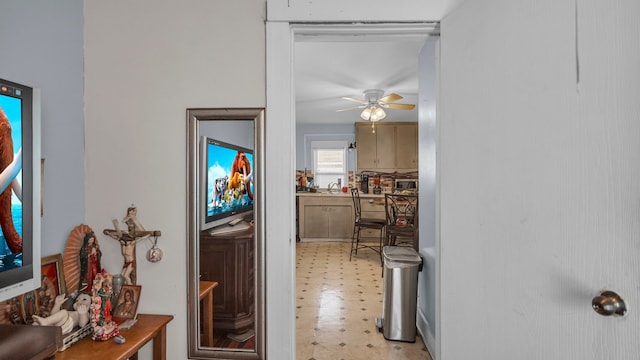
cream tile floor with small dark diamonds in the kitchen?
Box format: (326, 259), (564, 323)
(296, 242), (431, 360)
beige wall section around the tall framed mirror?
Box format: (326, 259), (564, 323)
(85, 0), (264, 359)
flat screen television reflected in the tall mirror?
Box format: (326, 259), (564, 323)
(201, 136), (255, 235)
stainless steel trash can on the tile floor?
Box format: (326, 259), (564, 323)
(376, 246), (422, 342)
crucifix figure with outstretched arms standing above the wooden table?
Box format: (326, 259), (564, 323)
(104, 205), (160, 285)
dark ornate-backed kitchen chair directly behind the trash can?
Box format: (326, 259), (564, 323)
(384, 193), (418, 251)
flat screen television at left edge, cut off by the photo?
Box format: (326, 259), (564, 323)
(0, 79), (41, 300)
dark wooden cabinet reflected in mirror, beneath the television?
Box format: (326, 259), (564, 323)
(200, 228), (255, 333)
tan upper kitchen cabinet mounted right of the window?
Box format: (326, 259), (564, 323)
(356, 123), (418, 172)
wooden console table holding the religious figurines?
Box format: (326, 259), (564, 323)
(55, 314), (173, 360)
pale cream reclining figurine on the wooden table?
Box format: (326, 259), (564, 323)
(33, 293), (91, 335)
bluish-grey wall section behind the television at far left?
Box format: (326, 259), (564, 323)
(0, 0), (85, 256)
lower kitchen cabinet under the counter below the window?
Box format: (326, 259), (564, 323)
(298, 195), (353, 240)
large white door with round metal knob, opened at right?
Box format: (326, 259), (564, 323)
(436, 0), (640, 360)
